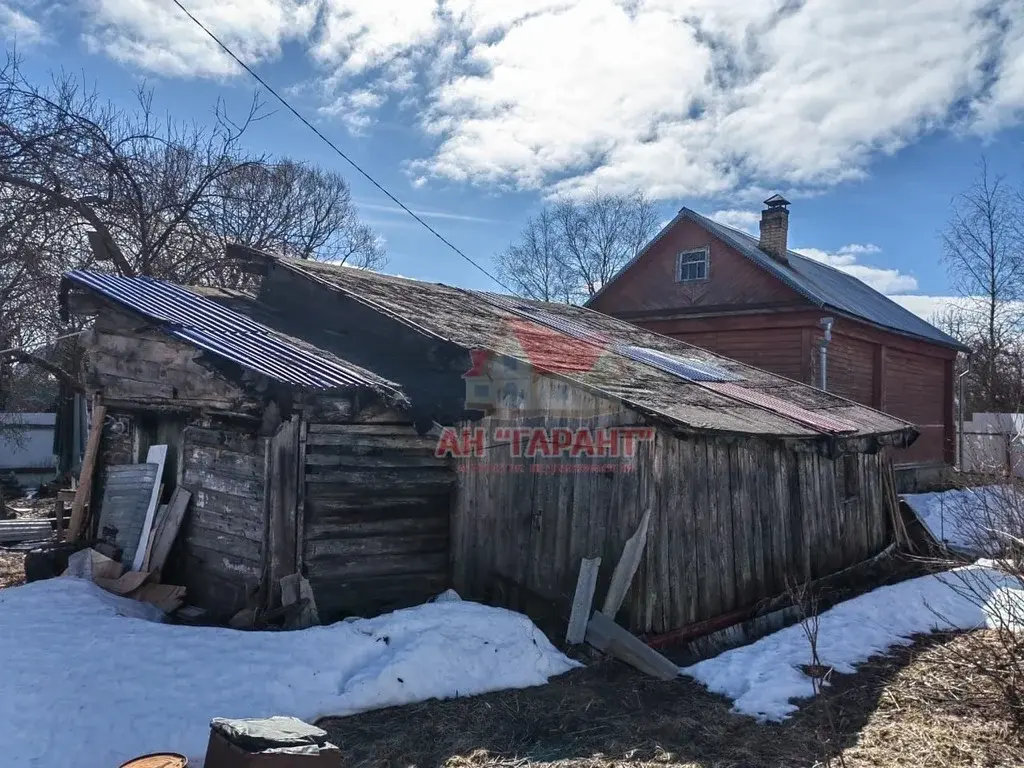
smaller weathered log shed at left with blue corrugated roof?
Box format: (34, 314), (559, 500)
(61, 271), (454, 621)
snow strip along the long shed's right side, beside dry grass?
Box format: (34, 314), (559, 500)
(683, 562), (1024, 720)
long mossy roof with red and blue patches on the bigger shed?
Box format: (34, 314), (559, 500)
(270, 258), (913, 440)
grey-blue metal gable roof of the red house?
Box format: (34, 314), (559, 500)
(591, 208), (967, 351)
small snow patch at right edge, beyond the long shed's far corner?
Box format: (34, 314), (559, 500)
(903, 485), (1024, 557)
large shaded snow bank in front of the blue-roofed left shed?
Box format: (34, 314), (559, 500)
(0, 578), (575, 768)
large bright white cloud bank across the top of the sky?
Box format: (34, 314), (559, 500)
(49, 0), (1024, 198)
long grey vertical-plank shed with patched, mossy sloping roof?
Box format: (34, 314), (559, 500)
(216, 251), (916, 633)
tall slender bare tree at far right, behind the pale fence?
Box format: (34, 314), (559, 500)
(943, 160), (1024, 411)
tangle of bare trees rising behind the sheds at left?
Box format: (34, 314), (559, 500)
(0, 56), (385, 408)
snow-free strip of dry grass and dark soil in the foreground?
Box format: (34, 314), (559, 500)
(322, 636), (1024, 768)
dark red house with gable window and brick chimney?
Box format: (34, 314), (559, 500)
(588, 196), (966, 465)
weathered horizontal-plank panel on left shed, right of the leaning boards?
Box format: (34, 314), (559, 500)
(179, 426), (266, 615)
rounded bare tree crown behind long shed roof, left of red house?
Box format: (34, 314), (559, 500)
(498, 190), (657, 302)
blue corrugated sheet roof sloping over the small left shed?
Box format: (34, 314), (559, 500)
(65, 269), (394, 390)
